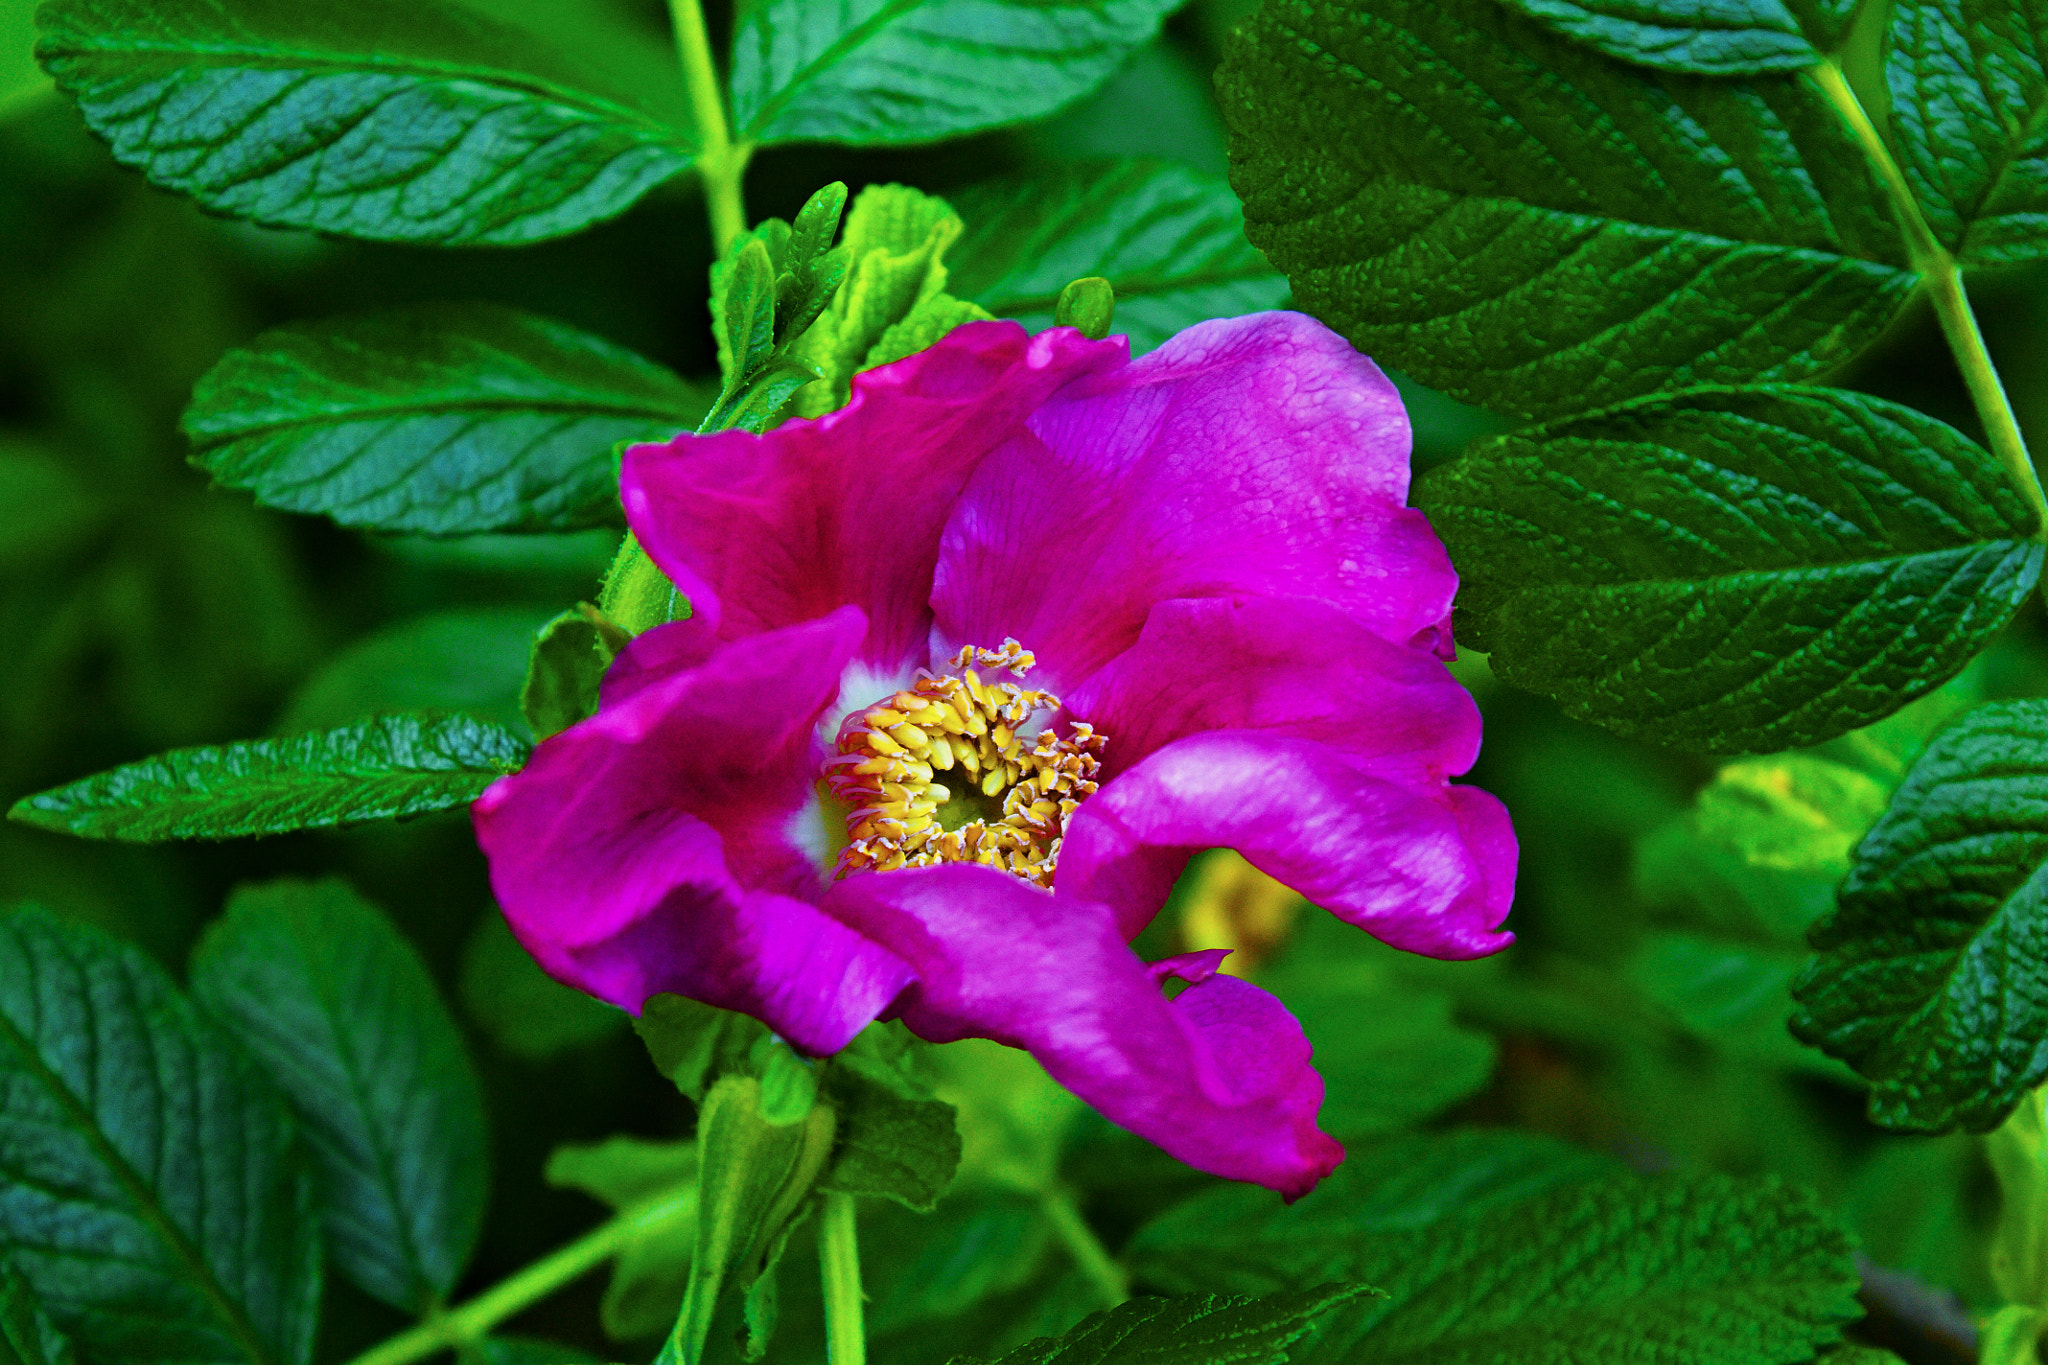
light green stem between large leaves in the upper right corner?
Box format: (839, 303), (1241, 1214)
(1812, 57), (2048, 544)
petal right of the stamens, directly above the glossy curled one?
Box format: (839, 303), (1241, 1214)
(1065, 598), (1481, 784)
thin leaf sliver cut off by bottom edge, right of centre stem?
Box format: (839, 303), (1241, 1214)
(954, 1285), (1378, 1365)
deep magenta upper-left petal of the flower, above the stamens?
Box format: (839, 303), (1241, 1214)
(618, 321), (1128, 671)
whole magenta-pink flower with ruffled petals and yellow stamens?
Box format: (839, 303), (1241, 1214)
(475, 313), (1516, 1197)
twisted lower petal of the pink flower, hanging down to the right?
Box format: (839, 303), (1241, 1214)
(823, 864), (1343, 1197)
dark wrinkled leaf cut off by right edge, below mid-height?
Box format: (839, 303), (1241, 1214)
(1792, 700), (2048, 1132)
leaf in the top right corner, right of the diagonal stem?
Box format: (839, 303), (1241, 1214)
(1884, 0), (2048, 264)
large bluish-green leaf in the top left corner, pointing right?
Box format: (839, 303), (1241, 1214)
(37, 0), (694, 246)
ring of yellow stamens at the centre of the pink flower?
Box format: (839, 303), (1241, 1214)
(825, 641), (1104, 888)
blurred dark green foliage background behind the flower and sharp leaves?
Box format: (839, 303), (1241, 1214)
(0, 0), (2048, 1359)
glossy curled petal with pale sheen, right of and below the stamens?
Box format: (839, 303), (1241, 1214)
(1053, 731), (1516, 958)
